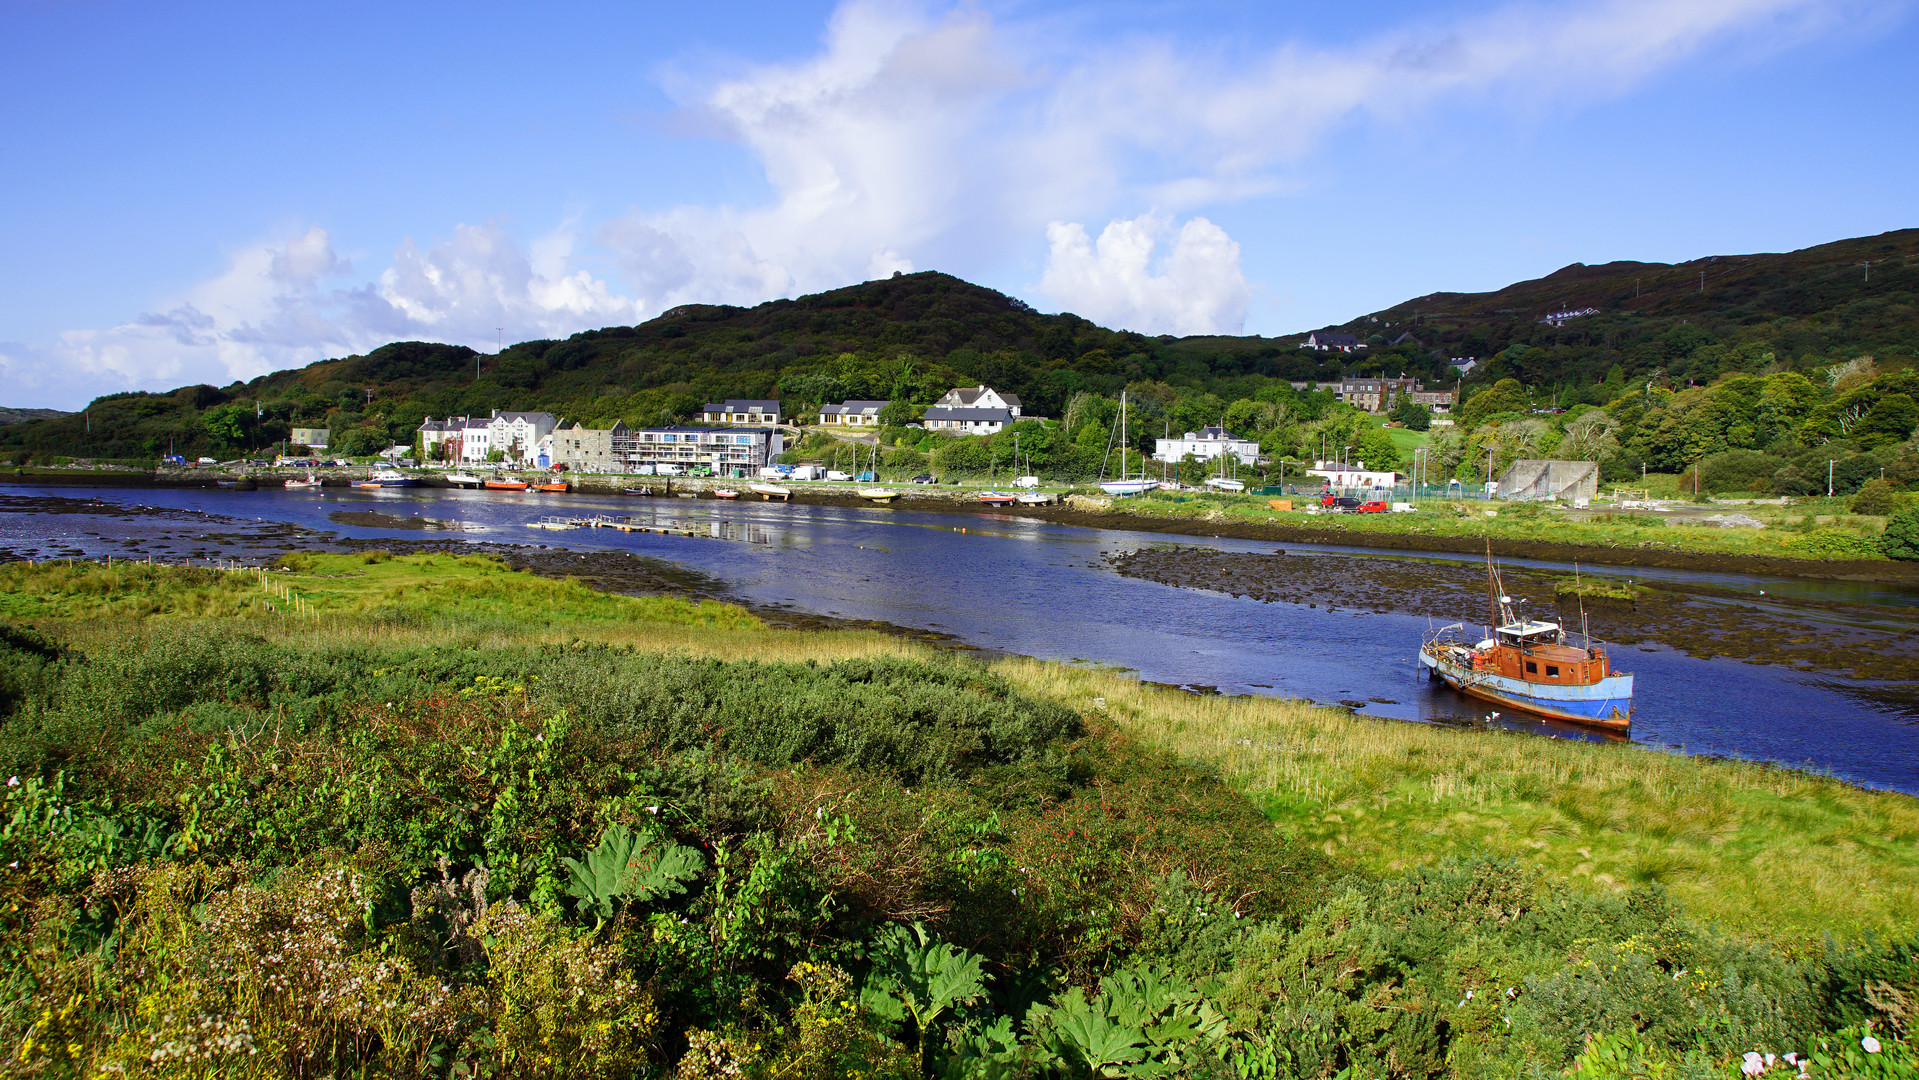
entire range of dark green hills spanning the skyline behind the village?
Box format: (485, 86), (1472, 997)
(0, 230), (1919, 458)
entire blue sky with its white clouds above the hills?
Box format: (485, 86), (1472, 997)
(0, 0), (1919, 409)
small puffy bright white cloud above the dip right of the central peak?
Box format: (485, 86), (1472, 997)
(1040, 215), (1251, 334)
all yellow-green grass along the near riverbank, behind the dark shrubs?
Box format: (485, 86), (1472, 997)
(0, 552), (1919, 938)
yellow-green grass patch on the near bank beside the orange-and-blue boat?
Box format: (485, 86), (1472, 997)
(998, 660), (1919, 938)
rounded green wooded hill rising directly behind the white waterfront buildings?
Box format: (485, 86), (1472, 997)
(0, 272), (1343, 458)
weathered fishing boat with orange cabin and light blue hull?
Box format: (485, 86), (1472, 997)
(1420, 549), (1633, 731)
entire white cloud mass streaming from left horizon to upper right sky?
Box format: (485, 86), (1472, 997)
(14, 0), (1872, 403)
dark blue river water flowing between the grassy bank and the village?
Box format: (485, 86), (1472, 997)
(0, 485), (1919, 794)
